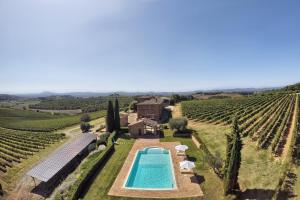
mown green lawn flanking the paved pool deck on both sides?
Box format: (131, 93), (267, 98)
(84, 132), (223, 200)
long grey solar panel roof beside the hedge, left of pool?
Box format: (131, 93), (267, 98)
(27, 133), (96, 182)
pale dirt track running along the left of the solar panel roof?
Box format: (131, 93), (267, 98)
(6, 118), (105, 200)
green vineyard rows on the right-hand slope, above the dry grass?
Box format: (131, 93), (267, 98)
(182, 95), (298, 156)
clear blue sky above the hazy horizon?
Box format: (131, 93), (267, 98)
(0, 0), (300, 93)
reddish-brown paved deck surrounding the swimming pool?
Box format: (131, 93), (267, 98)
(108, 139), (203, 199)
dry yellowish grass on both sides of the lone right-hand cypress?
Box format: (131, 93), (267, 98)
(192, 122), (284, 198)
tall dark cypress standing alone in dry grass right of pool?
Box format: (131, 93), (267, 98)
(224, 118), (242, 195)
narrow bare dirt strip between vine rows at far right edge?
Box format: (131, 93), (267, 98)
(281, 95), (299, 162)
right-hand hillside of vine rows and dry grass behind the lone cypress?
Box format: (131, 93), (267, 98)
(181, 94), (300, 199)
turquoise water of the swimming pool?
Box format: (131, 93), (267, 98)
(125, 147), (176, 190)
